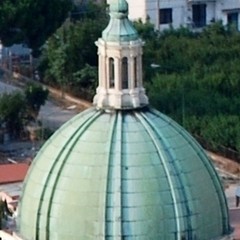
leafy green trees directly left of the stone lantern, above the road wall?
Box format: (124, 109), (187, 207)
(39, 2), (107, 99)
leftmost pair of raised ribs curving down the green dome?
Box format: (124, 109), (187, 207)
(35, 111), (101, 240)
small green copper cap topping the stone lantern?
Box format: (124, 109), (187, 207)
(102, 0), (138, 42)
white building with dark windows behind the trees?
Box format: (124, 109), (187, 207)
(125, 0), (240, 31)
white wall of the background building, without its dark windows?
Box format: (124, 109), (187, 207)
(127, 0), (240, 30)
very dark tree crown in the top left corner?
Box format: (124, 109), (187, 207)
(0, 0), (72, 54)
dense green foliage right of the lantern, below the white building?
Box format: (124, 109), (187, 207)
(144, 23), (240, 154)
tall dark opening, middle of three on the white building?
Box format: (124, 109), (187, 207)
(192, 4), (206, 28)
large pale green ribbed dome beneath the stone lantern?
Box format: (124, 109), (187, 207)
(18, 107), (229, 240)
